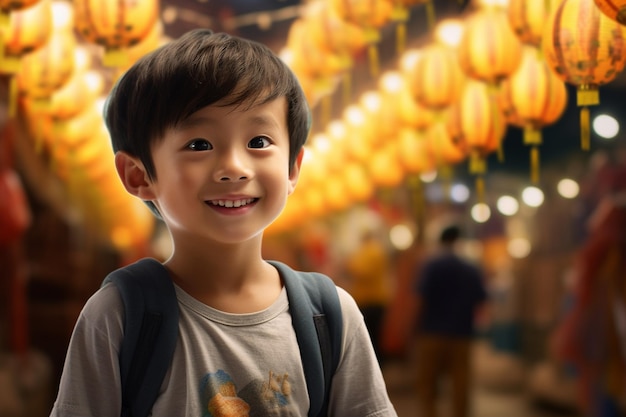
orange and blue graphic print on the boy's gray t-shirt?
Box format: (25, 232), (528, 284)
(200, 369), (296, 417)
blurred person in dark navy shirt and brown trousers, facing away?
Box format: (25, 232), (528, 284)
(414, 225), (487, 417)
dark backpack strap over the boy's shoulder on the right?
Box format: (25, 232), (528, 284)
(269, 261), (343, 417)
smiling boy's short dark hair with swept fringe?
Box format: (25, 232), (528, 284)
(104, 29), (311, 211)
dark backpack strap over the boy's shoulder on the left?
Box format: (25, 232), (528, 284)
(102, 258), (178, 417)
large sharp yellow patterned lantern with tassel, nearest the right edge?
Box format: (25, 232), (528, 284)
(542, 0), (626, 150)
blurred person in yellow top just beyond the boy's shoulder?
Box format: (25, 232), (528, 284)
(345, 230), (392, 363)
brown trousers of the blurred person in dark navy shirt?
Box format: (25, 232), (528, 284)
(417, 334), (471, 417)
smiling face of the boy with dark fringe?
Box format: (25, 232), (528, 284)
(130, 97), (301, 243)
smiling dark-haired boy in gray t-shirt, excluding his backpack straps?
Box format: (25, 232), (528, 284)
(52, 30), (396, 417)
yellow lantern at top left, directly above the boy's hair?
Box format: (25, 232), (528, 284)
(73, 0), (159, 67)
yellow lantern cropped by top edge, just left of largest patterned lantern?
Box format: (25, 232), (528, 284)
(507, 0), (555, 47)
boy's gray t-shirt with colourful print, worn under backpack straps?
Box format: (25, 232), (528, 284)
(51, 274), (396, 417)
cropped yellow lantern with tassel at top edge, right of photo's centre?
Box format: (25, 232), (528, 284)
(330, 0), (393, 77)
